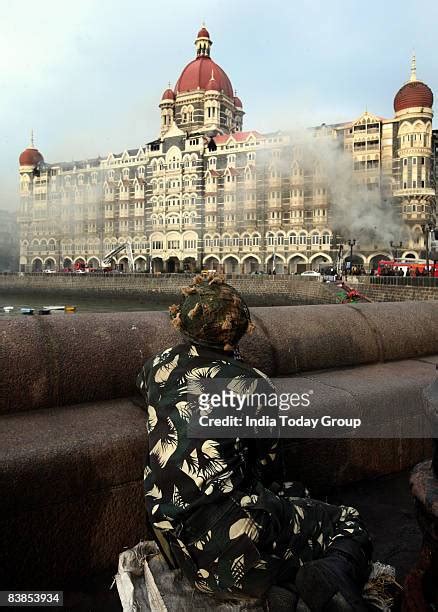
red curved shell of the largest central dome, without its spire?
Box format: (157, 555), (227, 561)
(175, 56), (233, 99)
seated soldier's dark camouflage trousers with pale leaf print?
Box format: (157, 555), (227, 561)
(172, 484), (370, 597)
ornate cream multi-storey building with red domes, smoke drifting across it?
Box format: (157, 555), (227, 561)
(19, 27), (438, 273)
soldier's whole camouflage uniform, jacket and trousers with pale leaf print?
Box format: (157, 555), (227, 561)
(137, 276), (368, 596)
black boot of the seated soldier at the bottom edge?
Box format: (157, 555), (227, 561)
(295, 538), (370, 612)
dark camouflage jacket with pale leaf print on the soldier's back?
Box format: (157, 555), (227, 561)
(137, 343), (277, 530)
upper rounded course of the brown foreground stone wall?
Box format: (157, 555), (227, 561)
(0, 302), (438, 414)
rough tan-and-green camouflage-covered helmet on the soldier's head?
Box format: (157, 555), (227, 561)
(169, 275), (254, 350)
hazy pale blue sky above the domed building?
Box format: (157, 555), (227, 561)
(0, 0), (438, 209)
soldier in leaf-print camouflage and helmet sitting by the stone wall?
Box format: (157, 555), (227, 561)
(137, 276), (371, 612)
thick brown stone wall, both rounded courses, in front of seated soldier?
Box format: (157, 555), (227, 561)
(0, 304), (438, 589)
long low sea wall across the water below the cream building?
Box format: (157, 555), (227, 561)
(0, 274), (337, 306)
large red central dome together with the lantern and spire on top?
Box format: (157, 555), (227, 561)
(175, 27), (234, 99)
